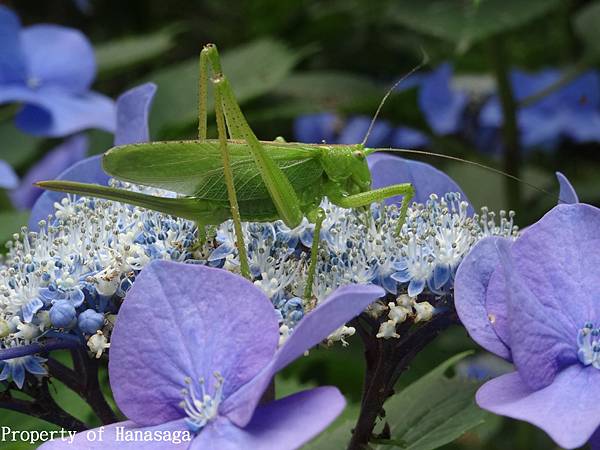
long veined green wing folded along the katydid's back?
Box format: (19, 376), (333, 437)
(103, 140), (323, 201)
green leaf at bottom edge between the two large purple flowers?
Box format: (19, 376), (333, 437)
(377, 352), (489, 450)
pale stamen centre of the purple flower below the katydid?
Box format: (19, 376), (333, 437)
(180, 372), (224, 433)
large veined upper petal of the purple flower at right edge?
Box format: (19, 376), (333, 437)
(498, 203), (600, 389)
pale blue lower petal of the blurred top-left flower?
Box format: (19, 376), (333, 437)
(14, 88), (116, 137)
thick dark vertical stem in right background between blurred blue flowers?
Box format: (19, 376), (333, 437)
(489, 36), (521, 211)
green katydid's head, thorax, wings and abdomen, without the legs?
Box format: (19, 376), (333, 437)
(98, 140), (378, 226)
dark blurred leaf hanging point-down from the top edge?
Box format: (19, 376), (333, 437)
(392, 0), (560, 52)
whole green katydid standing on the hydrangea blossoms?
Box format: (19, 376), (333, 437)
(38, 45), (414, 288)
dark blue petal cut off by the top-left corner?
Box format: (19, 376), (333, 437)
(0, 5), (26, 84)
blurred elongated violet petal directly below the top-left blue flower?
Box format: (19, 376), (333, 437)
(10, 134), (88, 209)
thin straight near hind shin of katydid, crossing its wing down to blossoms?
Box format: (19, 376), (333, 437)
(215, 79), (250, 279)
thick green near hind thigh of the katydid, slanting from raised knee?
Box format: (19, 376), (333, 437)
(203, 46), (304, 227)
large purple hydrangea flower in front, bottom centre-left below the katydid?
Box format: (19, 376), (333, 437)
(41, 261), (383, 450)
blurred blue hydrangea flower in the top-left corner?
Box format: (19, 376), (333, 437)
(0, 6), (116, 137)
